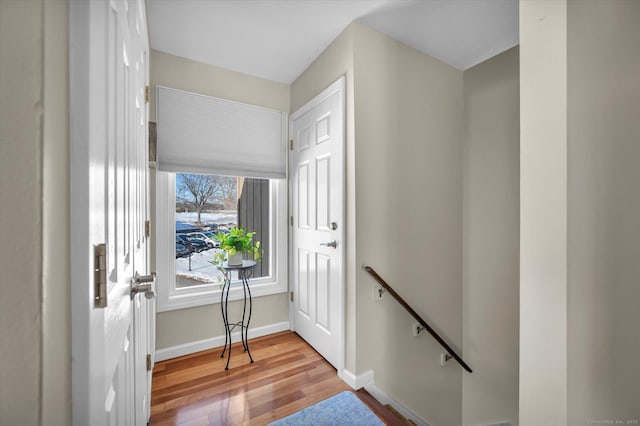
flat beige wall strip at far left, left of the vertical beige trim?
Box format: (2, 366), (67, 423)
(0, 1), (44, 425)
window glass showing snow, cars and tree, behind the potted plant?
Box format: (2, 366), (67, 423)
(176, 174), (271, 288)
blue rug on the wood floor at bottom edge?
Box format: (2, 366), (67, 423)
(269, 391), (384, 426)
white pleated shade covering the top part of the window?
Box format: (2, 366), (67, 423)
(156, 86), (287, 179)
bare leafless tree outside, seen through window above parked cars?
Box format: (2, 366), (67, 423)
(176, 174), (237, 224)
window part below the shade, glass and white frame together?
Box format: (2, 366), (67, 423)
(156, 171), (287, 311)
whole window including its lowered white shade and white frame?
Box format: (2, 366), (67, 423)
(156, 86), (288, 311)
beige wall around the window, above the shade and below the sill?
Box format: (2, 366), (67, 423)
(150, 50), (289, 349)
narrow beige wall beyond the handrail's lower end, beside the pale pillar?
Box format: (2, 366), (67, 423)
(462, 47), (520, 426)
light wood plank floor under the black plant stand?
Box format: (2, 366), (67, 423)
(150, 331), (350, 425)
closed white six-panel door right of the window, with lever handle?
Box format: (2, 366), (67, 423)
(290, 77), (345, 371)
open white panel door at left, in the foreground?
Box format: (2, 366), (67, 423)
(69, 0), (154, 426)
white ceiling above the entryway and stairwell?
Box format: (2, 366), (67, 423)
(147, 0), (518, 84)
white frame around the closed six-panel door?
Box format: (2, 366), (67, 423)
(287, 75), (347, 380)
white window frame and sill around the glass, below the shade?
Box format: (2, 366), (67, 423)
(155, 171), (288, 312)
